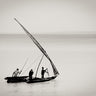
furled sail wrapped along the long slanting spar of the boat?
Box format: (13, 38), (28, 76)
(14, 18), (59, 76)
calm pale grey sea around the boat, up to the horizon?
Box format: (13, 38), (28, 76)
(0, 34), (96, 96)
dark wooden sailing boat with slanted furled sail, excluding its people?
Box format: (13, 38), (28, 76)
(5, 18), (59, 83)
